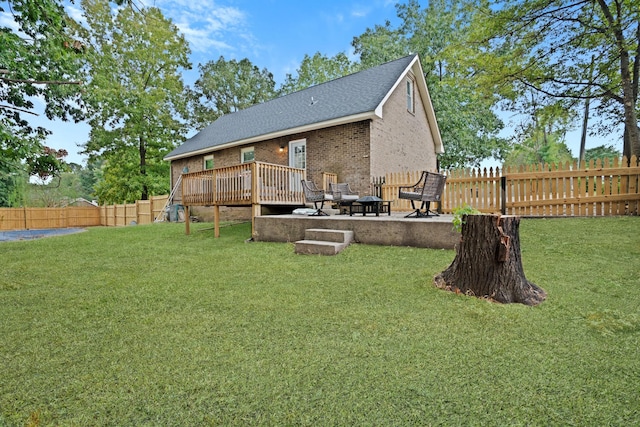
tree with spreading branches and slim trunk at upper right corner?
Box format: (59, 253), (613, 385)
(474, 0), (640, 157)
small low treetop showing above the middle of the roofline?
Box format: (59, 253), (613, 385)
(280, 52), (359, 95)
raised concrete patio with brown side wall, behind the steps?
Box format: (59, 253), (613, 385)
(253, 212), (460, 249)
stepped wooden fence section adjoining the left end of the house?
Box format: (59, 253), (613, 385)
(99, 194), (169, 227)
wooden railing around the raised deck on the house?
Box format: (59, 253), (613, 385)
(182, 162), (305, 206)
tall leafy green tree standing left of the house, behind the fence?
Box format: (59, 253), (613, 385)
(82, 0), (190, 203)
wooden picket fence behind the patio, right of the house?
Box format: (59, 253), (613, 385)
(382, 156), (640, 216)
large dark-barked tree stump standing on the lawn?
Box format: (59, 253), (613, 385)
(434, 215), (547, 305)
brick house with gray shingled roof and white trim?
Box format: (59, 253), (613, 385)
(165, 55), (444, 217)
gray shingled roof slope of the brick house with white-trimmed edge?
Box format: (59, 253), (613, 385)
(165, 55), (415, 159)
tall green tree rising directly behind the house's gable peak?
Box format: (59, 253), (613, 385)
(352, 0), (508, 168)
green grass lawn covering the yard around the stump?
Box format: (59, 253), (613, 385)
(0, 218), (640, 426)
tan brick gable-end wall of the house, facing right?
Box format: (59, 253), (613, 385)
(371, 74), (437, 176)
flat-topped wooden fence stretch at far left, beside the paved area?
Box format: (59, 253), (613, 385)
(0, 206), (100, 230)
